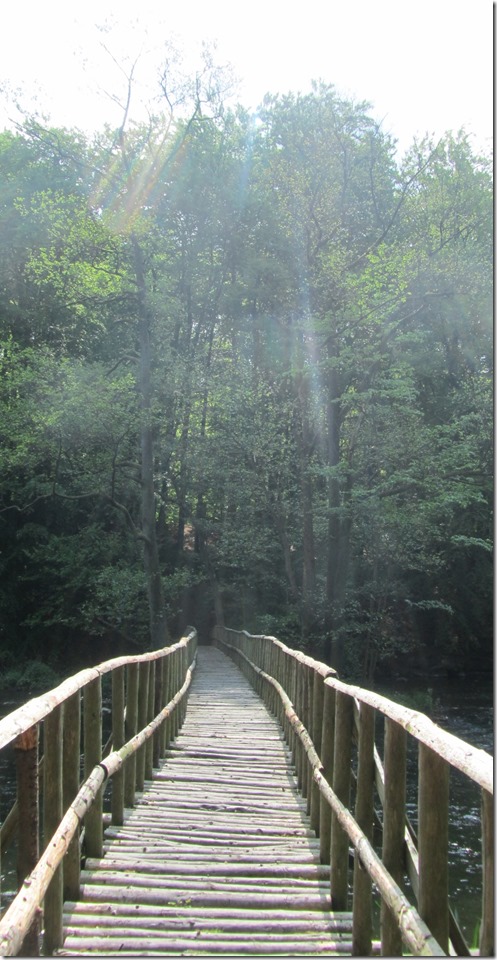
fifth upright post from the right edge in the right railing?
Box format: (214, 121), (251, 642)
(331, 691), (354, 910)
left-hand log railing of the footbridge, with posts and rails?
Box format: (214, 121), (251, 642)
(0, 630), (197, 957)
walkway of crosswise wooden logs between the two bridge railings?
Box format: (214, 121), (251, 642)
(59, 647), (352, 956)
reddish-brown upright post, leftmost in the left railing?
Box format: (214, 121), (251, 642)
(14, 724), (40, 957)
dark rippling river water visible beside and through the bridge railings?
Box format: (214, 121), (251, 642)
(0, 678), (494, 946)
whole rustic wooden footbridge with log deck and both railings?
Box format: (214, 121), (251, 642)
(0, 627), (494, 957)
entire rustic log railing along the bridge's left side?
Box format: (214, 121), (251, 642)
(0, 629), (197, 956)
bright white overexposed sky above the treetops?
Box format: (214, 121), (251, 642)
(0, 0), (493, 158)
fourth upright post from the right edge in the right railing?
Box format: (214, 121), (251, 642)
(352, 703), (375, 957)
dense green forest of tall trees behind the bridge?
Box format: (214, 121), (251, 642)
(0, 60), (493, 682)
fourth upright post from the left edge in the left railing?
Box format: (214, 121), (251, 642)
(83, 677), (103, 858)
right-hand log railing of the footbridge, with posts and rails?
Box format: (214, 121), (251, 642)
(215, 627), (494, 956)
